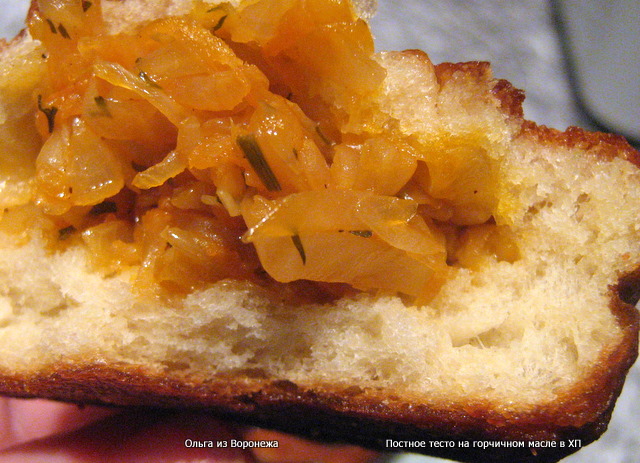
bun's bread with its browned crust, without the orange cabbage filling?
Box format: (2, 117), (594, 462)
(0, 0), (640, 461)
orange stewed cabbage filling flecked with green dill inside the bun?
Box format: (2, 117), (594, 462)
(5, 0), (517, 302)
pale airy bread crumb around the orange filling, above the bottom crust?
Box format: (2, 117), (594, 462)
(0, 2), (640, 416)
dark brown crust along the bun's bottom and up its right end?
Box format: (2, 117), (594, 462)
(0, 286), (639, 462)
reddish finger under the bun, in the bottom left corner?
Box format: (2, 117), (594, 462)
(0, 409), (255, 463)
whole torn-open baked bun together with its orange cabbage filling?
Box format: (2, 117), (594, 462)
(0, 0), (640, 462)
